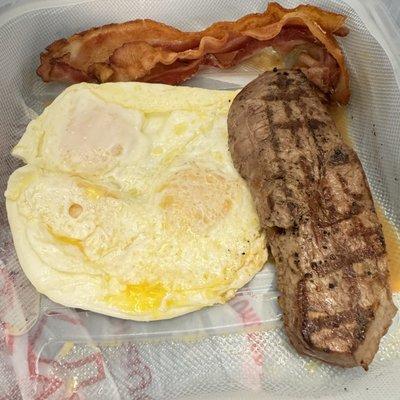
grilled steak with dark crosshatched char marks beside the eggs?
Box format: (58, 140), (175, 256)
(228, 71), (396, 369)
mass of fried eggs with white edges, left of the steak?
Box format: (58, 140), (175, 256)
(6, 83), (267, 320)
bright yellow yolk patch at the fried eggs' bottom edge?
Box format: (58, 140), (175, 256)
(105, 283), (167, 313)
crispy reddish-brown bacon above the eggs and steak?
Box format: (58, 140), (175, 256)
(37, 3), (350, 103)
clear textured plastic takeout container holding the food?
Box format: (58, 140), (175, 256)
(0, 0), (400, 400)
